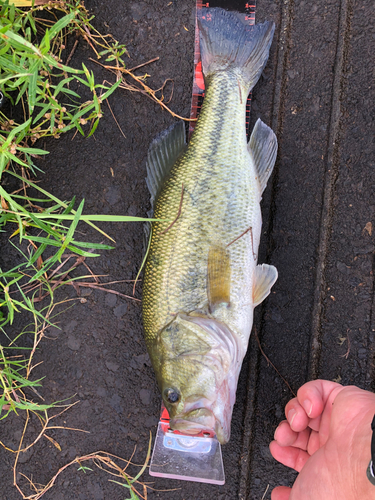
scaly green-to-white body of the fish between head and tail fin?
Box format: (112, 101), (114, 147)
(143, 74), (260, 342)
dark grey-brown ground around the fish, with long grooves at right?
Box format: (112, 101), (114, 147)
(0, 0), (375, 500)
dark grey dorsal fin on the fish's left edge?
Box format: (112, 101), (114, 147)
(146, 121), (186, 216)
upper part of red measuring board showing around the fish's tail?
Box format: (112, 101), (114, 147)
(189, 0), (256, 137)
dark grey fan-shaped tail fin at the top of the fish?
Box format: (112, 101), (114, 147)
(198, 8), (275, 91)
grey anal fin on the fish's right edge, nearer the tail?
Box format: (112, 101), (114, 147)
(248, 119), (277, 193)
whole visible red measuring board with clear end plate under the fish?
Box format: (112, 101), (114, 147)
(149, 0), (255, 485)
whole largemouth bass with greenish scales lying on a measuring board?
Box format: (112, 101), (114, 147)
(142, 8), (277, 444)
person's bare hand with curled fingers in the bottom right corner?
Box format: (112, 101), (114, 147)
(270, 380), (375, 500)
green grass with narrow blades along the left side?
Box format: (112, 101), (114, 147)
(0, 0), (150, 419)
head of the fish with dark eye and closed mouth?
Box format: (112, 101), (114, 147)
(157, 314), (242, 443)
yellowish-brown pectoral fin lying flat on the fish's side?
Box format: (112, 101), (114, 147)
(207, 245), (231, 312)
